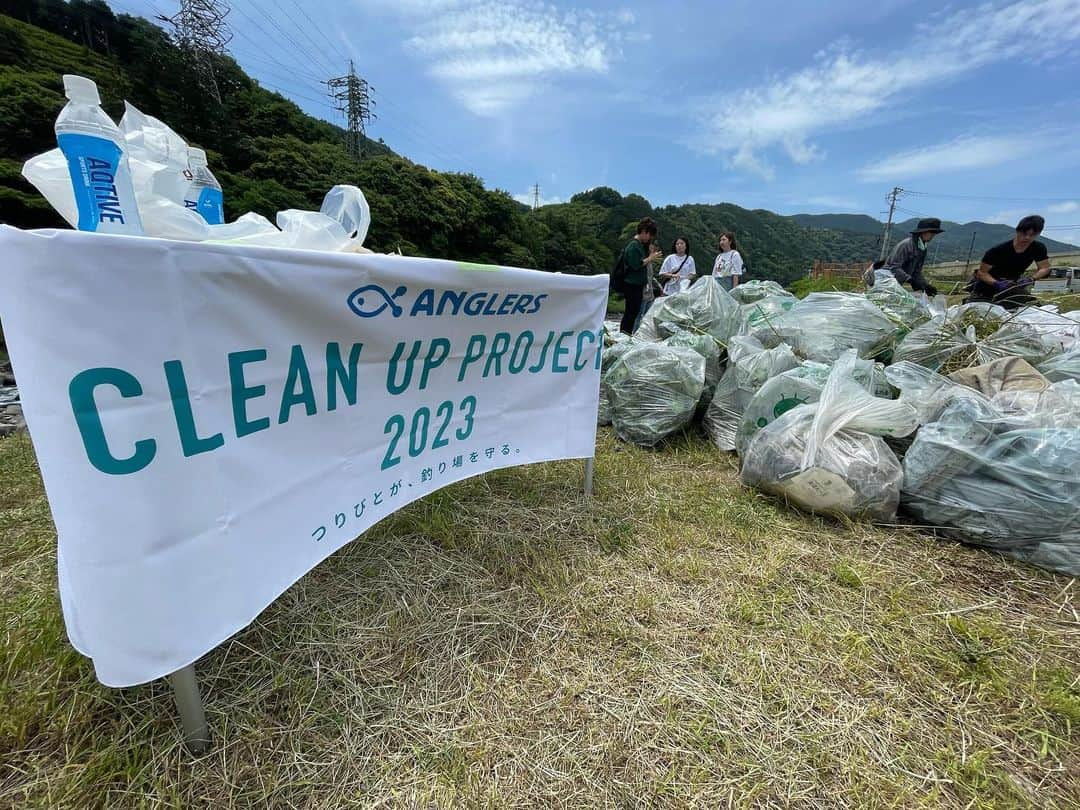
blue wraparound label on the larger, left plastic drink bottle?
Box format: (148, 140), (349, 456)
(56, 133), (143, 233)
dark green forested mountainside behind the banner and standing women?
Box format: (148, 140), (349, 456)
(0, 0), (1067, 283)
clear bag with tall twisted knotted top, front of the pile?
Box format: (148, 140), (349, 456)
(741, 351), (917, 521)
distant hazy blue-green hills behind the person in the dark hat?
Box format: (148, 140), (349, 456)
(788, 214), (1077, 261)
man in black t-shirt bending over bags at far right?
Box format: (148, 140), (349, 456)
(967, 214), (1050, 309)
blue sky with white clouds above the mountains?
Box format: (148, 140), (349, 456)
(113, 0), (1080, 244)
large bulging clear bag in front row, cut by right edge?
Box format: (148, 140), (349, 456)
(903, 381), (1080, 577)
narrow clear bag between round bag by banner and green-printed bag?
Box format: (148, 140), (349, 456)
(702, 336), (799, 451)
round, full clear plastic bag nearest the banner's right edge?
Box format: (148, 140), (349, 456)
(605, 340), (705, 447)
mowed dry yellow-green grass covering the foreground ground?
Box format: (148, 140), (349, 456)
(0, 429), (1080, 809)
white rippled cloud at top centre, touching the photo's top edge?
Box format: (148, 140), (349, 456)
(380, 0), (636, 117)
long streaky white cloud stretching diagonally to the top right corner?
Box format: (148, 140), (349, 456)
(693, 0), (1080, 177)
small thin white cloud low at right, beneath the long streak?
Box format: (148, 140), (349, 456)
(859, 133), (1058, 183)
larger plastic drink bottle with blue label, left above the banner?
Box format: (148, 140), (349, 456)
(56, 75), (143, 234)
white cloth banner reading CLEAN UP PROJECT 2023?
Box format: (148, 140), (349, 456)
(0, 228), (607, 687)
